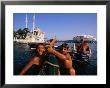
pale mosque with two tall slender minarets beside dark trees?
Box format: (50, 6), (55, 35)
(14, 14), (45, 43)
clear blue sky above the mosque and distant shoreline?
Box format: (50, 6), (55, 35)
(13, 13), (97, 40)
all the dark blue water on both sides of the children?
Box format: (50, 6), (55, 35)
(13, 42), (97, 75)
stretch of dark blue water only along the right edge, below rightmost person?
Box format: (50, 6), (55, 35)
(74, 43), (97, 75)
